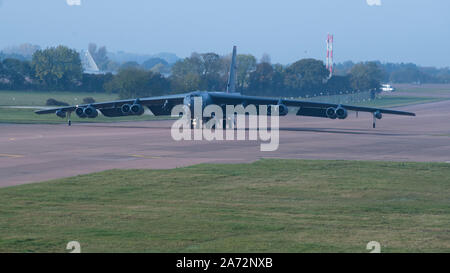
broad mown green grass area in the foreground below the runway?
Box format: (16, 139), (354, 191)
(0, 160), (450, 252)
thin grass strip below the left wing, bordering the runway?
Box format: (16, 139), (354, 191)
(0, 107), (171, 124)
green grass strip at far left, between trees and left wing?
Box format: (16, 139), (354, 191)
(0, 90), (118, 106)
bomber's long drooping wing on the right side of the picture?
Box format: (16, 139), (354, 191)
(210, 92), (416, 116)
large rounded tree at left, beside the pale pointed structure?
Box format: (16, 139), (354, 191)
(31, 46), (83, 89)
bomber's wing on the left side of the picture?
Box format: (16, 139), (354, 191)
(35, 94), (186, 115)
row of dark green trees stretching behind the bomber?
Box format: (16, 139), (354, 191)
(0, 46), (384, 98)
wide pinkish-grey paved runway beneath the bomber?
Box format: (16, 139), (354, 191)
(0, 101), (450, 187)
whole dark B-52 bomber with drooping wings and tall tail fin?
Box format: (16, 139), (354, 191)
(36, 46), (415, 128)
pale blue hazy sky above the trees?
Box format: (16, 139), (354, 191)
(0, 0), (450, 67)
